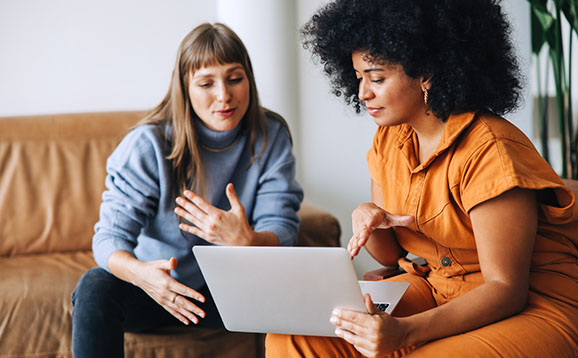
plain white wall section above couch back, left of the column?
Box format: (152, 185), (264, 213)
(0, 0), (216, 115)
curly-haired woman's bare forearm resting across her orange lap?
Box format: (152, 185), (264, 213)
(399, 281), (527, 346)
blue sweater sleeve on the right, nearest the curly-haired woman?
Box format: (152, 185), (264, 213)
(253, 120), (303, 246)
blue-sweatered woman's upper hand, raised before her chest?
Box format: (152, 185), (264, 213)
(175, 183), (255, 246)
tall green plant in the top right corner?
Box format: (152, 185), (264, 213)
(528, 0), (578, 179)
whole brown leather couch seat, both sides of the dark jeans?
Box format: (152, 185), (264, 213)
(0, 251), (264, 358)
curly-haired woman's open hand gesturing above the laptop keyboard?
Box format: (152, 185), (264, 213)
(347, 203), (414, 258)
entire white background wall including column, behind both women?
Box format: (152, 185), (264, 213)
(0, 0), (531, 273)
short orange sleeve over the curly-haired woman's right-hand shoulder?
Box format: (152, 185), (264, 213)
(450, 114), (560, 210)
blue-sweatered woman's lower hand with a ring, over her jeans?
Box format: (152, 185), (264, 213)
(108, 251), (205, 325)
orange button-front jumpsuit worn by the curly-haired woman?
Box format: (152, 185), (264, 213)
(266, 112), (578, 358)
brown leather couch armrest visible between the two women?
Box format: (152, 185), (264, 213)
(297, 199), (341, 247)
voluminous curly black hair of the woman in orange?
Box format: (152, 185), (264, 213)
(301, 0), (522, 120)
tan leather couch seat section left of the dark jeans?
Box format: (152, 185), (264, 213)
(0, 251), (95, 358)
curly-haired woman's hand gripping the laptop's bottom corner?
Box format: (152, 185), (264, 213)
(330, 294), (405, 357)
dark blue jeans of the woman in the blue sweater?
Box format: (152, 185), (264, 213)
(72, 268), (223, 358)
